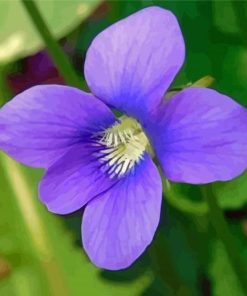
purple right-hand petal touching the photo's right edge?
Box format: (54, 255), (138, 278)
(146, 88), (247, 184)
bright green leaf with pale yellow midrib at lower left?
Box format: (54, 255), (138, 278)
(0, 154), (151, 296)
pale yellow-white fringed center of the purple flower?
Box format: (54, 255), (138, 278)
(93, 117), (148, 178)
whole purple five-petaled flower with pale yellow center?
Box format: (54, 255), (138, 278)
(0, 7), (247, 270)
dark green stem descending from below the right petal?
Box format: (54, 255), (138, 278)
(203, 185), (247, 295)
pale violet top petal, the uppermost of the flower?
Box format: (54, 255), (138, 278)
(85, 7), (185, 119)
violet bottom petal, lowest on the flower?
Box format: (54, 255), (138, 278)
(82, 155), (162, 270)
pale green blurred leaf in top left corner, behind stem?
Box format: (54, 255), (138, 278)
(0, 0), (102, 64)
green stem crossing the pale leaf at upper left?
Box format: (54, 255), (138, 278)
(21, 0), (83, 88)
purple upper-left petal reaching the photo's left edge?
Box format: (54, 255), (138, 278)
(0, 85), (115, 167)
